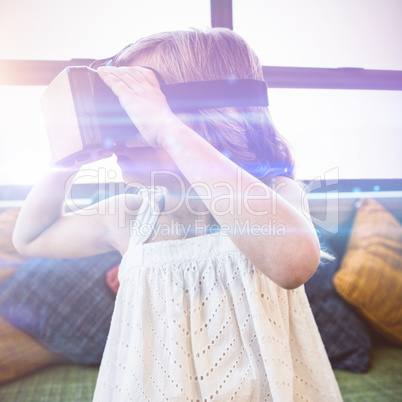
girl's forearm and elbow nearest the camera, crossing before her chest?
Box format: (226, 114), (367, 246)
(164, 124), (320, 289)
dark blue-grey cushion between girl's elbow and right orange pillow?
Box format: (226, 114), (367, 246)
(305, 232), (371, 373)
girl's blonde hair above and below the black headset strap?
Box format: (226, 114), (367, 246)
(116, 28), (294, 182)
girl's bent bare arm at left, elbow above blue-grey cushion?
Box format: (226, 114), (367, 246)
(13, 169), (137, 258)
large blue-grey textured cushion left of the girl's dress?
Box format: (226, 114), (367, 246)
(0, 252), (121, 365)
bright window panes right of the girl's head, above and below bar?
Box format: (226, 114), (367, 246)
(233, 0), (402, 179)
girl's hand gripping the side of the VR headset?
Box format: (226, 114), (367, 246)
(98, 66), (178, 148)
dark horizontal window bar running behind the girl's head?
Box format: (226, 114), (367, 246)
(0, 59), (402, 91)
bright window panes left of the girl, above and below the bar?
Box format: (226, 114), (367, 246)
(0, 0), (211, 185)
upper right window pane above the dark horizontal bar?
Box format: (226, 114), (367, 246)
(233, 0), (402, 70)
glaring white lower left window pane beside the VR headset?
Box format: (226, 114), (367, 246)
(0, 86), (122, 185)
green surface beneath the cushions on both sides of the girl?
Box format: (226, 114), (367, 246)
(0, 346), (402, 402)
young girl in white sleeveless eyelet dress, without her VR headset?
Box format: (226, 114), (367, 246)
(14, 29), (341, 402)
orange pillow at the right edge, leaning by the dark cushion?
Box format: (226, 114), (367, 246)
(334, 199), (402, 345)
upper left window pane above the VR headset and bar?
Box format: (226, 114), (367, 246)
(0, 0), (210, 60)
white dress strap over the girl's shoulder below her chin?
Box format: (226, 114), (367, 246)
(129, 188), (165, 247)
